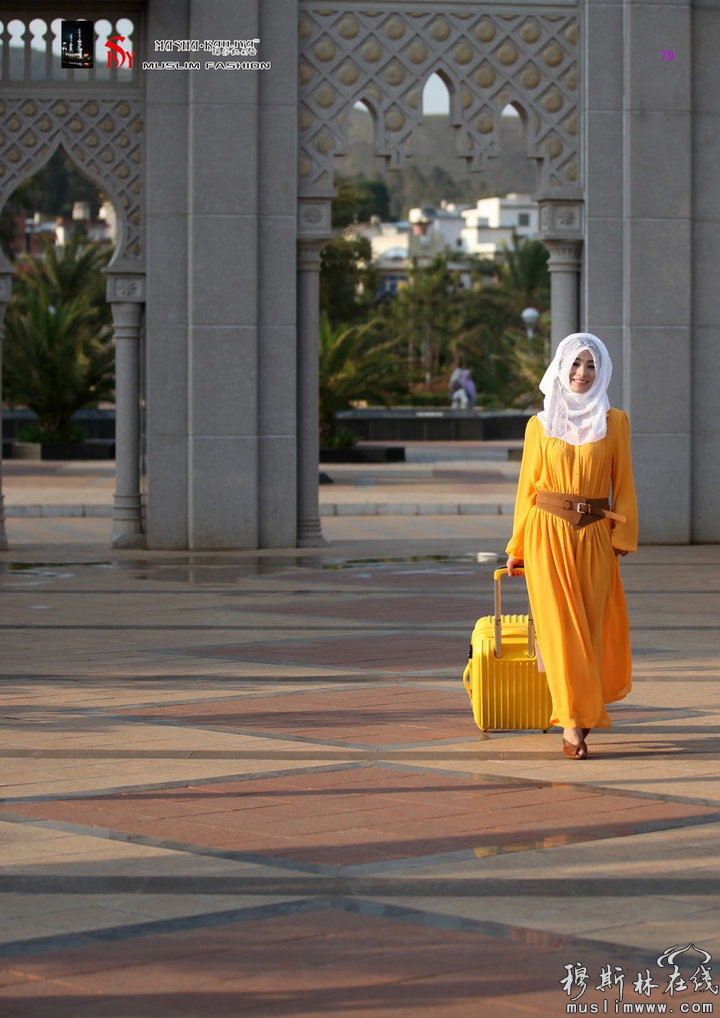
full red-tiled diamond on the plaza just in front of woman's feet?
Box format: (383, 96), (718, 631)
(13, 767), (720, 866)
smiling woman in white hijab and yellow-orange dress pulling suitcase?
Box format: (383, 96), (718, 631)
(506, 332), (638, 759)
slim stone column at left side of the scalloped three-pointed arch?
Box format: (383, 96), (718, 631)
(297, 240), (326, 548)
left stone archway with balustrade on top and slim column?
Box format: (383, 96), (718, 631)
(0, 3), (145, 547)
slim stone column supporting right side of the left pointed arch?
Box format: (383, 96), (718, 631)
(108, 276), (146, 548)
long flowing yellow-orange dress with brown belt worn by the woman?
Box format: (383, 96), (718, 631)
(506, 409), (638, 728)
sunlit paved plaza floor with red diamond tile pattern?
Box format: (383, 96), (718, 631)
(0, 450), (720, 1018)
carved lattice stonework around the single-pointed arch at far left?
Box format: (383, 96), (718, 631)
(0, 96), (145, 269)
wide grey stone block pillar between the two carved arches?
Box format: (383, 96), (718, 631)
(146, 0), (297, 549)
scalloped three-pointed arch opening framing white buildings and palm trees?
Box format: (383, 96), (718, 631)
(321, 94), (548, 430)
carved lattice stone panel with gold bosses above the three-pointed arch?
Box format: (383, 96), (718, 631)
(299, 0), (579, 195)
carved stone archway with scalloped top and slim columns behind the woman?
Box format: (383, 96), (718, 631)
(298, 0), (583, 545)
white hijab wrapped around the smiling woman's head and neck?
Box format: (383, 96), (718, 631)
(538, 332), (612, 445)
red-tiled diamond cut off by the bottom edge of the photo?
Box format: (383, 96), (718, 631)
(0, 910), (631, 1018)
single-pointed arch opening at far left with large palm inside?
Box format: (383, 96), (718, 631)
(0, 147), (118, 541)
